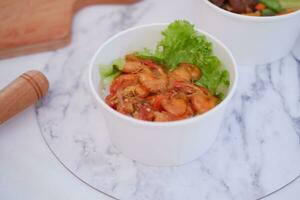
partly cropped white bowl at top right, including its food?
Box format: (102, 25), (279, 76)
(196, 0), (300, 65)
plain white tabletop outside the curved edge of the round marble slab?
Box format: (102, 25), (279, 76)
(0, 104), (300, 200)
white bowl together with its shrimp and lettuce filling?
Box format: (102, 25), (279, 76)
(89, 20), (238, 166)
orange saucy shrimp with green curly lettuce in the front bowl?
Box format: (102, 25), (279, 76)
(100, 20), (230, 122)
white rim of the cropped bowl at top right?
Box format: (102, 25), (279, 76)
(201, 0), (300, 22)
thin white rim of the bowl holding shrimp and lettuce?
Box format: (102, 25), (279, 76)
(88, 23), (238, 127)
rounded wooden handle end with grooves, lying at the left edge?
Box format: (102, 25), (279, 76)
(0, 70), (49, 124)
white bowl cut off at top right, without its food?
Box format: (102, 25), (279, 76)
(196, 0), (300, 65)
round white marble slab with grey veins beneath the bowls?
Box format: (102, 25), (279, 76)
(0, 0), (300, 200)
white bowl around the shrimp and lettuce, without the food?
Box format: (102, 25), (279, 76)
(89, 24), (238, 166)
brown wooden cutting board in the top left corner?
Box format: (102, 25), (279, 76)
(0, 0), (137, 58)
